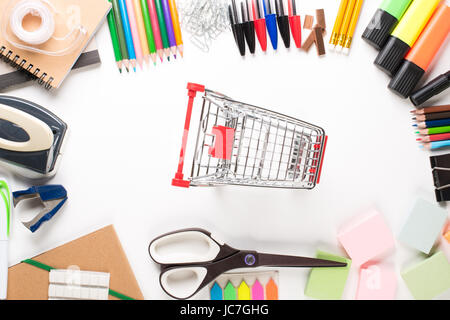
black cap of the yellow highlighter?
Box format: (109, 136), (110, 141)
(374, 36), (411, 77)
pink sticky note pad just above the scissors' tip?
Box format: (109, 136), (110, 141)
(338, 209), (395, 265)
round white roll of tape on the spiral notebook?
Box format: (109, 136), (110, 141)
(9, 0), (55, 45)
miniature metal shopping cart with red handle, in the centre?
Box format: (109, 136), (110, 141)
(172, 83), (327, 189)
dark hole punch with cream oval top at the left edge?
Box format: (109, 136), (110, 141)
(0, 95), (67, 179)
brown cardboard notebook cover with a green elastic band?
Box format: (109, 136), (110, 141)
(7, 225), (144, 300)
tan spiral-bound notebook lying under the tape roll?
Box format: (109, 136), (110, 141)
(0, 0), (111, 89)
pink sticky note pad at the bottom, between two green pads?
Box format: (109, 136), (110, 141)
(356, 264), (397, 300)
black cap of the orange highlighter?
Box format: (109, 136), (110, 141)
(388, 60), (425, 99)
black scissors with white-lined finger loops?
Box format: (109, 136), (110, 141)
(148, 228), (347, 300)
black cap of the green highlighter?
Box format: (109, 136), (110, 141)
(362, 9), (398, 50)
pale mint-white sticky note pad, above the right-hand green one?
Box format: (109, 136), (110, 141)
(399, 199), (447, 254)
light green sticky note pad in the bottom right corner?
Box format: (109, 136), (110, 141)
(402, 252), (450, 300)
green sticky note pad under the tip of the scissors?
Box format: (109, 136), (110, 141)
(305, 250), (352, 300)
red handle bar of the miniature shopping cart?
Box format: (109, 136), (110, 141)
(172, 82), (205, 188)
